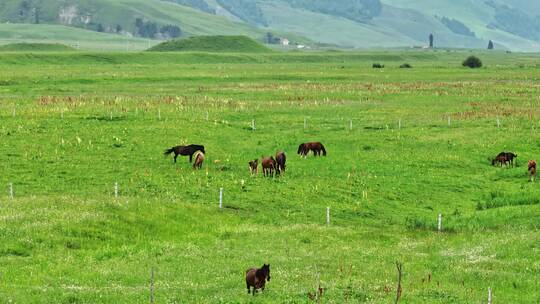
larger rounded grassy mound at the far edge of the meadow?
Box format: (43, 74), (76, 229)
(149, 36), (270, 53)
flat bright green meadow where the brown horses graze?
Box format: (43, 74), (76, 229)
(0, 50), (540, 303)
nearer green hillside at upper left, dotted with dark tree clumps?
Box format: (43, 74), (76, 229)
(0, 0), (264, 38)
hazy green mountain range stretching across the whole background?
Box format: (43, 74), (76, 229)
(0, 0), (540, 51)
